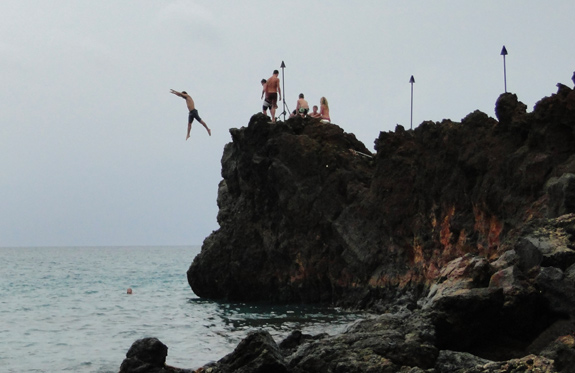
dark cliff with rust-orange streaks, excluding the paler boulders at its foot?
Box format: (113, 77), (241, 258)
(188, 86), (575, 309)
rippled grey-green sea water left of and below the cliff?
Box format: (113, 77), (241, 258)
(0, 246), (360, 372)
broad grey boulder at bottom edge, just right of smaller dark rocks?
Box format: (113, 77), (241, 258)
(288, 312), (438, 373)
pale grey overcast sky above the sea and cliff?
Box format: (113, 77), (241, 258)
(0, 0), (575, 247)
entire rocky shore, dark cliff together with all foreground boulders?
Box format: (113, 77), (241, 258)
(120, 80), (575, 373)
